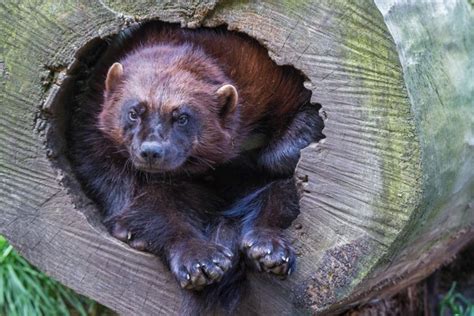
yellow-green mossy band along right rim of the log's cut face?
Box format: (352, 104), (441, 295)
(340, 0), (421, 294)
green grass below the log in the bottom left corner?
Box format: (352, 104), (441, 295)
(0, 236), (107, 316)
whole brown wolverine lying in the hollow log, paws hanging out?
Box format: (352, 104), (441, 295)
(68, 23), (324, 315)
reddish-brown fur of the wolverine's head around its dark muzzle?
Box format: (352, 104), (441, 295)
(99, 45), (239, 173)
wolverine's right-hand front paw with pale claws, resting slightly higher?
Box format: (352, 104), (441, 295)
(241, 229), (295, 277)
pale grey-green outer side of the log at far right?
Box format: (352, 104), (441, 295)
(378, 1), (474, 249)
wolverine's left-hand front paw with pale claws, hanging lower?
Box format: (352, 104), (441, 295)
(170, 241), (234, 290)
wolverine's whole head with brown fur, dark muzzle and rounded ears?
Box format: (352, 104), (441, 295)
(99, 45), (239, 173)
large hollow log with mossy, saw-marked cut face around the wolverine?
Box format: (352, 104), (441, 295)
(0, 0), (474, 315)
